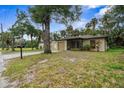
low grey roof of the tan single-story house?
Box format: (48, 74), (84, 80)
(62, 35), (107, 40)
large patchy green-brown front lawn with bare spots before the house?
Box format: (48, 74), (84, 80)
(3, 50), (124, 88)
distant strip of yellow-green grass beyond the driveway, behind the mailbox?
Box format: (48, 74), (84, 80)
(0, 48), (41, 54)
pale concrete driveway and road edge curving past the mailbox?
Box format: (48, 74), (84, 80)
(0, 51), (43, 88)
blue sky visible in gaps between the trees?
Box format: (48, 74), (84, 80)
(0, 5), (108, 32)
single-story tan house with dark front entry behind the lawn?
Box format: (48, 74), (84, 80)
(51, 35), (107, 52)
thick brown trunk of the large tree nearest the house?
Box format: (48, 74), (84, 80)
(44, 16), (51, 54)
